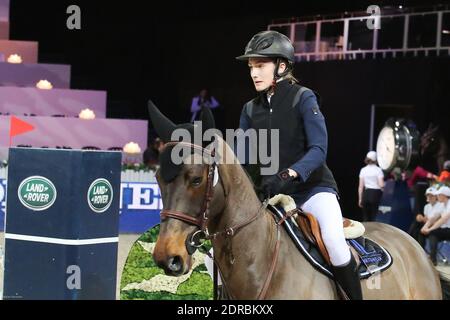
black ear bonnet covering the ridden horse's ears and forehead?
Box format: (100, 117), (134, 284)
(148, 100), (215, 183)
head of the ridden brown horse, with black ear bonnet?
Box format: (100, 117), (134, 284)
(149, 103), (230, 276)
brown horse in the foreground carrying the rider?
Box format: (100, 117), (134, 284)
(151, 102), (442, 300)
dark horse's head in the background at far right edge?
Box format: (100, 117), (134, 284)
(420, 123), (450, 172)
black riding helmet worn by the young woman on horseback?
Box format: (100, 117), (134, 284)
(236, 30), (295, 80)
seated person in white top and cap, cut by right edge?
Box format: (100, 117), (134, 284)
(421, 186), (450, 265)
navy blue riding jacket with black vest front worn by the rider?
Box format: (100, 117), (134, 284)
(239, 80), (338, 205)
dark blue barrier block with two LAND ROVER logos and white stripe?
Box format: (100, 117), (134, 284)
(3, 148), (121, 299)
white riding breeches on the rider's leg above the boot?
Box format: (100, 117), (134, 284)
(301, 192), (350, 266)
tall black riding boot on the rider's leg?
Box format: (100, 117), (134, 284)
(333, 255), (362, 300)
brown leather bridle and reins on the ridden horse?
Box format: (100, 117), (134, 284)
(156, 141), (284, 299)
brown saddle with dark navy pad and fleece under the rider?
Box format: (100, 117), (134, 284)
(269, 194), (392, 279)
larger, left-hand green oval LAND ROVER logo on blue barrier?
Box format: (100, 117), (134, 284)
(17, 176), (56, 211)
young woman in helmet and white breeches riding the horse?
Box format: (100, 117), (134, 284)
(237, 31), (362, 300)
